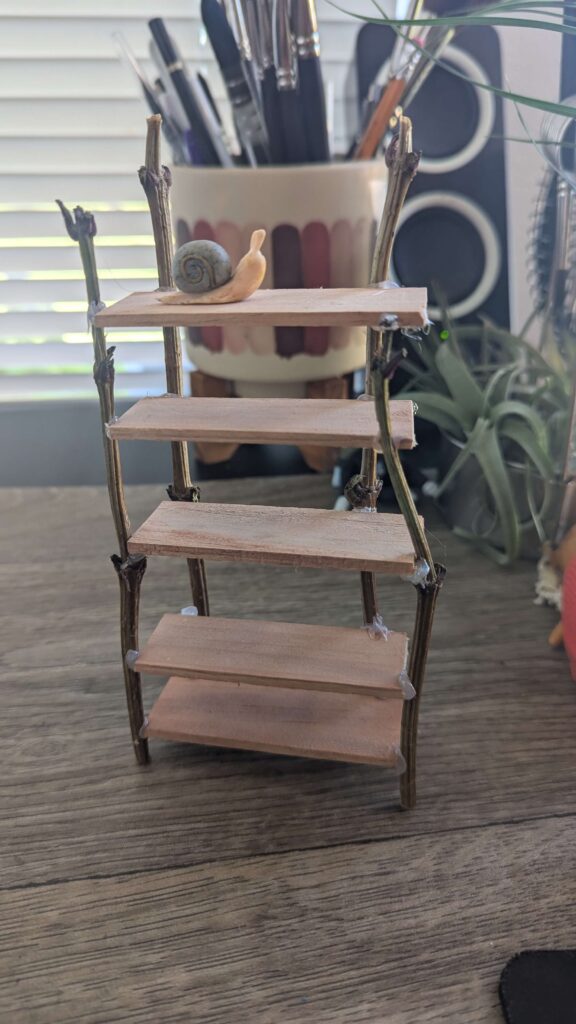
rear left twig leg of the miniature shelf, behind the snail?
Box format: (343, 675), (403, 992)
(138, 114), (210, 615)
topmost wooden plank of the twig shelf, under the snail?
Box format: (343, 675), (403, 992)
(95, 288), (427, 328)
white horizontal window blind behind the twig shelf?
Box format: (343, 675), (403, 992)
(0, 0), (373, 401)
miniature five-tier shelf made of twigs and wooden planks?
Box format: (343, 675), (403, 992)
(69, 118), (445, 808)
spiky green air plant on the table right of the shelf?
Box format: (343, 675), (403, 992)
(402, 319), (571, 564)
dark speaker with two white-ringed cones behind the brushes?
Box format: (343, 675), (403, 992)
(358, 26), (509, 326)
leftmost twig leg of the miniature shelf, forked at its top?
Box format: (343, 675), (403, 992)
(57, 201), (149, 764)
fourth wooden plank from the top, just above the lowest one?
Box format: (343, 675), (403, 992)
(136, 614), (408, 699)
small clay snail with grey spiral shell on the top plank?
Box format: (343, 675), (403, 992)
(158, 228), (266, 305)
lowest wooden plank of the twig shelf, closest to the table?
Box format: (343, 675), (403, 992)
(142, 676), (404, 771)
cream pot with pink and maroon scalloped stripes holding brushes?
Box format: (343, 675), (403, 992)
(172, 161), (386, 396)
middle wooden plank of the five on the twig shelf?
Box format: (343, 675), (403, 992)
(128, 502), (414, 574)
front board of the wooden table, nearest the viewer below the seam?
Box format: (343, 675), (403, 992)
(0, 815), (576, 1024)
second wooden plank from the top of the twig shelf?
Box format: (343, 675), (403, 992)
(109, 394), (415, 452)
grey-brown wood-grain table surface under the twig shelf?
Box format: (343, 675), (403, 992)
(0, 477), (576, 1024)
